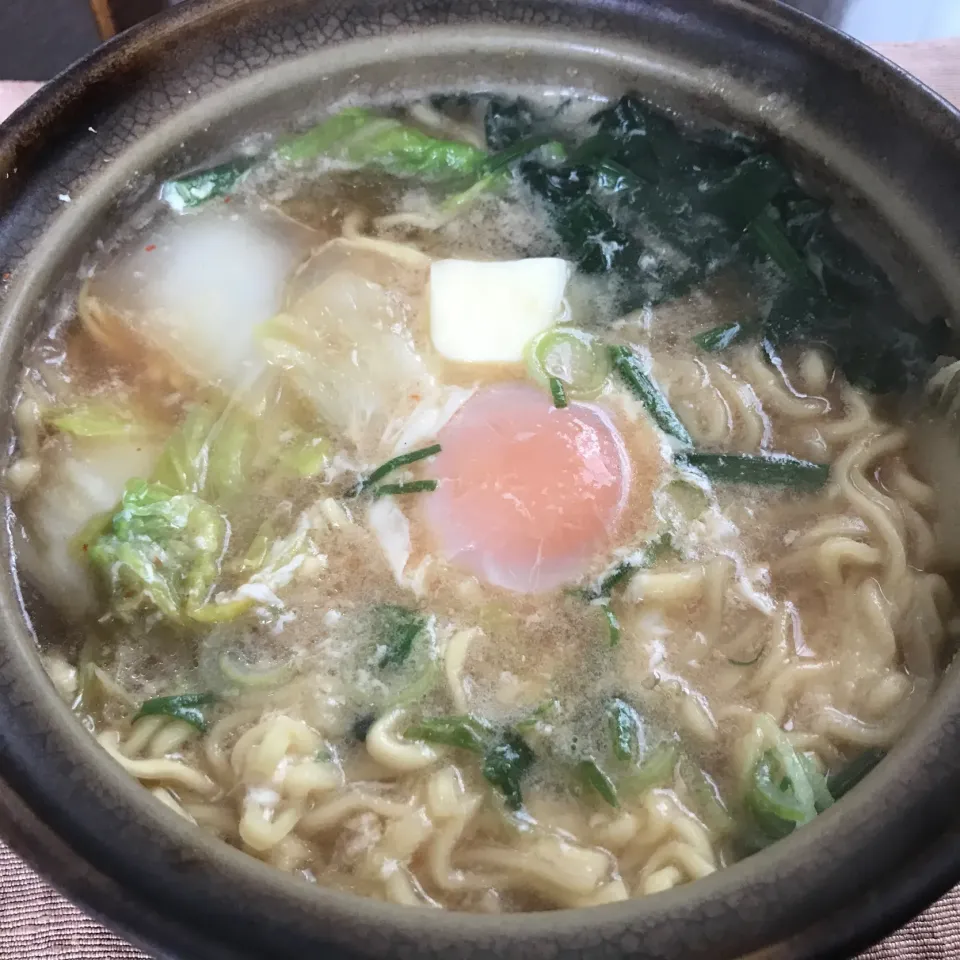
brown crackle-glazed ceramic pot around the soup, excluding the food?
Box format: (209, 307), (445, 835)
(0, 0), (960, 960)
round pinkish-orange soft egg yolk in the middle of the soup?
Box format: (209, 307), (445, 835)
(423, 384), (630, 593)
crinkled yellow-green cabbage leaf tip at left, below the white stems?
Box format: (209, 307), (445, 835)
(87, 480), (226, 622)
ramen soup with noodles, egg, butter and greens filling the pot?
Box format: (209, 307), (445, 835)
(6, 95), (960, 913)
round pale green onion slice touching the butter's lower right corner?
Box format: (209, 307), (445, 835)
(524, 327), (610, 396)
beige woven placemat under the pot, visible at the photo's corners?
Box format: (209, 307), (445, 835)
(0, 35), (960, 960)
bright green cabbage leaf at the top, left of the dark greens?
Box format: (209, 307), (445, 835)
(277, 107), (487, 180)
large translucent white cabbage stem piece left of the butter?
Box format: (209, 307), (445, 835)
(80, 204), (313, 392)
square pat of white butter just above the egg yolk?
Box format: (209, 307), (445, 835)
(430, 257), (570, 363)
